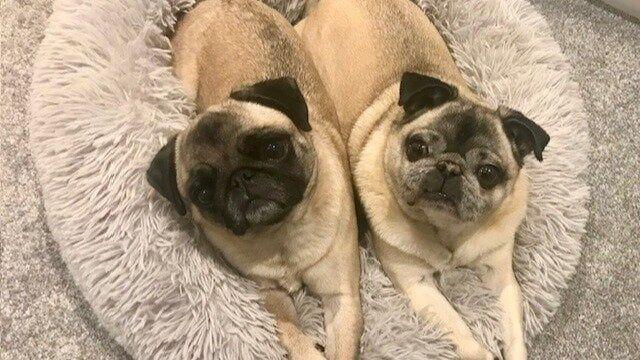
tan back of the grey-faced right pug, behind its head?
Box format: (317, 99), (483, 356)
(297, 0), (463, 137)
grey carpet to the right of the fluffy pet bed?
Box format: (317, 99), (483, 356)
(531, 0), (640, 359)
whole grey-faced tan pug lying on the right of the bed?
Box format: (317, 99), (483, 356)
(296, 0), (549, 359)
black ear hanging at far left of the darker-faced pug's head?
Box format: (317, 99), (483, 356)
(147, 136), (187, 215)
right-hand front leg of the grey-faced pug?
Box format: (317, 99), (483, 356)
(481, 244), (527, 360)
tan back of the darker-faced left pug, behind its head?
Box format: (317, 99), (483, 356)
(171, 0), (337, 133)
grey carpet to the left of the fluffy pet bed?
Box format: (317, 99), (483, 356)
(0, 0), (126, 360)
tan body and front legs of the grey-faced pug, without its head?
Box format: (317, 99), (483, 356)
(296, 0), (528, 360)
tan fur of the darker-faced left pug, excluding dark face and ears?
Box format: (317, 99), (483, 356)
(172, 0), (362, 360)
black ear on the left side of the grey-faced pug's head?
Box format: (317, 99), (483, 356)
(398, 72), (458, 116)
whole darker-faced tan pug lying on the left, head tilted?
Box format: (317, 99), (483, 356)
(147, 0), (362, 360)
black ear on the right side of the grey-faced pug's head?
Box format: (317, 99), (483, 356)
(502, 110), (551, 166)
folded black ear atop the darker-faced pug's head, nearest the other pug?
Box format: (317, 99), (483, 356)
(230, 76), (311, 131)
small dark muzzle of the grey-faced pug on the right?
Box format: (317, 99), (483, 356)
(422, 161), (462, 203)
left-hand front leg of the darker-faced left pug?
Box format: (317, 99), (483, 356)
(262, 284), (325, 360)
